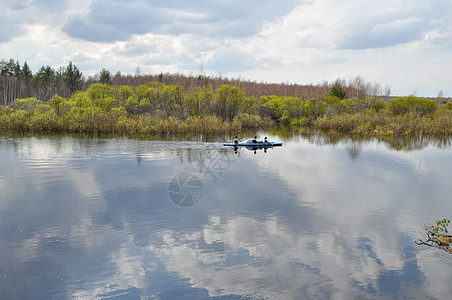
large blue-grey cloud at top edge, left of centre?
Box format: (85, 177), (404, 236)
(63, 0), (297, 42)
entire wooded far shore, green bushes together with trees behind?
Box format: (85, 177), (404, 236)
(0, 59), (452, 136)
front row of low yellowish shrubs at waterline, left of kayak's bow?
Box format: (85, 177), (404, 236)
(0, 106), (272, 135)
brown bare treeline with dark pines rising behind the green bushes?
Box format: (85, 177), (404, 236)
(0, 59), (391, 105)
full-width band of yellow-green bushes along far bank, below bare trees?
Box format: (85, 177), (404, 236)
(0, 83), (452, 136)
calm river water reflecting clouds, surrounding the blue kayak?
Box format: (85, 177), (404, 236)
(0, 133), (452, 299)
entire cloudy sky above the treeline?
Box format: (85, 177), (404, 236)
(0, 0), (452, 97)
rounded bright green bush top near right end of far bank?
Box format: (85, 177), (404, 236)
(387, 96), (437, 115)
